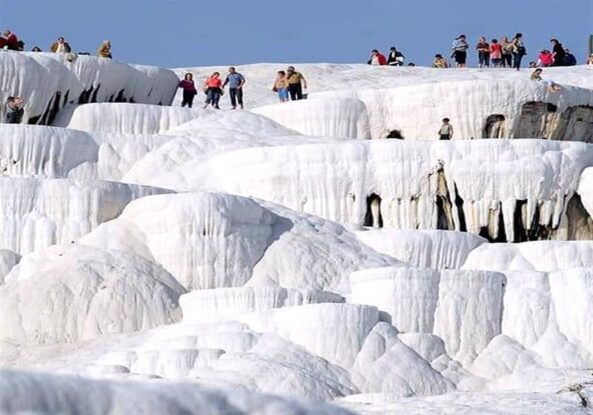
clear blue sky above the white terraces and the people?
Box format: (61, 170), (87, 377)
(0, 0), (593, 67)
